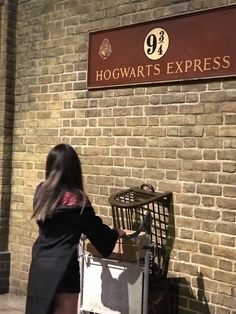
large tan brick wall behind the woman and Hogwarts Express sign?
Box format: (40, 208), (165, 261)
(7, 0), (236, 314)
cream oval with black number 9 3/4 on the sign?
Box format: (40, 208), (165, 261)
(144, 28), (169, 60)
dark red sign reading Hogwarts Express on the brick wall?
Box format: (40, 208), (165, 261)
(87, 5), (236, 89)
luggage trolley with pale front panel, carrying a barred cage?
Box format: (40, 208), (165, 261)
(80, 184), (172, 314)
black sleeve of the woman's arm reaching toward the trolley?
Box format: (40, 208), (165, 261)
(82, 207), (118, 257)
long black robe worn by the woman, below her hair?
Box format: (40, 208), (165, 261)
(25, 205), (118, 314)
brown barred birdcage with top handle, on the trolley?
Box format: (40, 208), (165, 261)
(109, 184), (172, 278)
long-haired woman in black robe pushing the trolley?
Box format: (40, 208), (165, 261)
(25, 144), (125, 314)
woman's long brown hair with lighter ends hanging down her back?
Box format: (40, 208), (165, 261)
(32, 144), (85, 220)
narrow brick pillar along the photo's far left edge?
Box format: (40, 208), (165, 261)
(0, 1), (17, 293)
